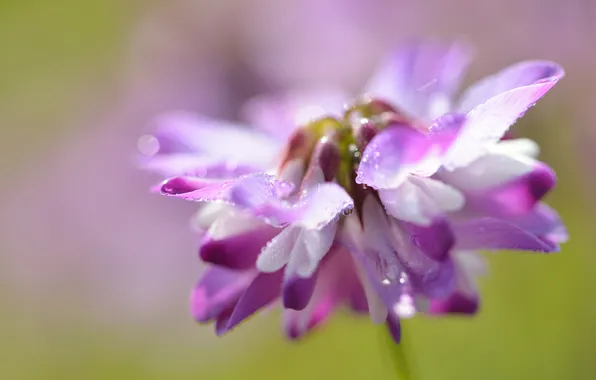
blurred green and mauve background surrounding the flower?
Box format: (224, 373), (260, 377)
(0, 0), (596, 380)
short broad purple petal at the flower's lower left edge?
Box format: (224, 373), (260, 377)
(191, 267), (252, 322)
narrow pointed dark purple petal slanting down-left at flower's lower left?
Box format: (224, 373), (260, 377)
(216, 271), (283, 335)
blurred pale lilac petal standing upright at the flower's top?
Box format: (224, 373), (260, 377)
(366, 43), (470, 120)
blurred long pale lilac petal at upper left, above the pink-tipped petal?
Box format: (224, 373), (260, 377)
(147, 112), (280, 169)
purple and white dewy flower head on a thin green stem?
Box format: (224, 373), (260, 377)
(143, 44), (567, 341)
